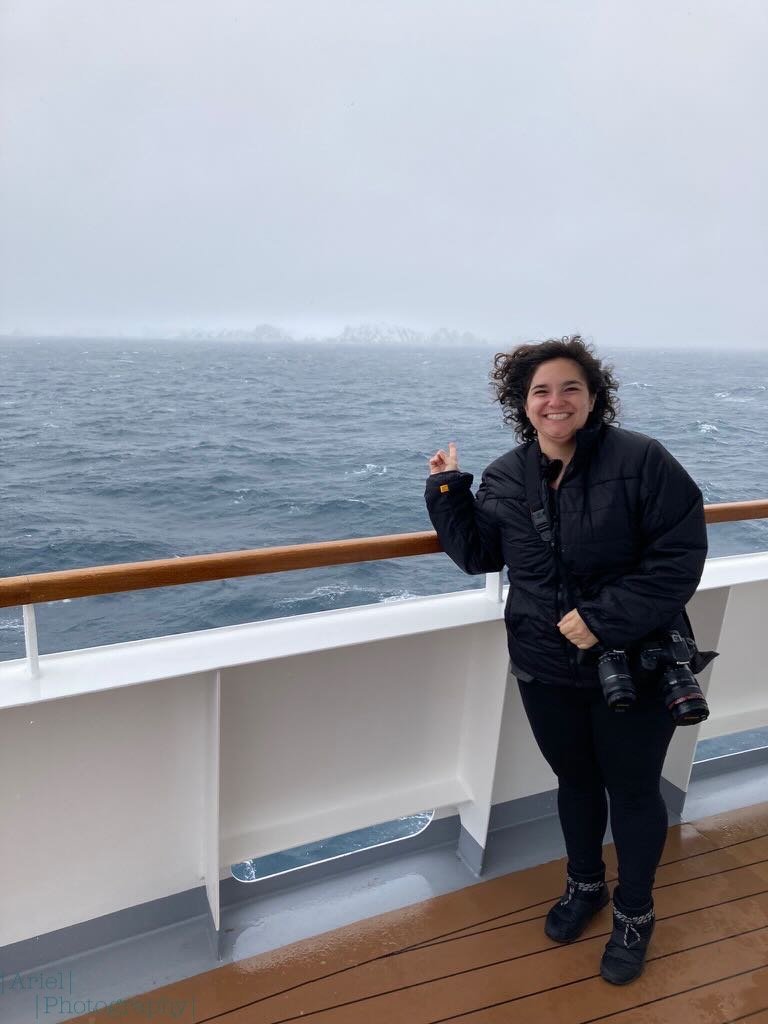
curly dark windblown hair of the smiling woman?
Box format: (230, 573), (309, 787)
(490, 334), (618, 441)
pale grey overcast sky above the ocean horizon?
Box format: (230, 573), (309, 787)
(0, 0), (768, 345)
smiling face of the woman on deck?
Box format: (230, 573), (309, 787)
(525, 358), (595, 458)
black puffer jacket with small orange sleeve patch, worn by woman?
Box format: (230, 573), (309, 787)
(425, 424), (707, 686)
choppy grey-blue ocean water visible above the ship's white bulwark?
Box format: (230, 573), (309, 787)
(0, 340), (768, 658)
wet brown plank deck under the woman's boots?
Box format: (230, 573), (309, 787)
(72, 803), (768, 1024)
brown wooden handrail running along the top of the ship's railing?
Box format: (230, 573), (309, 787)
(0, 500), (768, 608)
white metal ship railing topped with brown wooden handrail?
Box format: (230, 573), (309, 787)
(0, 502), (768, 946)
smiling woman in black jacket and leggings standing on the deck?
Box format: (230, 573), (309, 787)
(425, 336), (707, 984)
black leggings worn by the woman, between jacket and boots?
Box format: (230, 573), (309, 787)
(518, 680), (675, 908)
